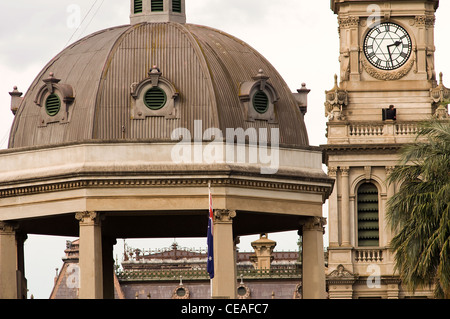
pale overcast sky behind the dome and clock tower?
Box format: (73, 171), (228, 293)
(0, 0), (450, 299)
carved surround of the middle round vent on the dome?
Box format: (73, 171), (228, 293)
(131, 65), (179, 120)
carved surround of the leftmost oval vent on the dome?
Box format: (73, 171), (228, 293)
(34, 72), (75, 127)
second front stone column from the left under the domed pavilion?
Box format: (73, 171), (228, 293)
(75, 212), (103, 299)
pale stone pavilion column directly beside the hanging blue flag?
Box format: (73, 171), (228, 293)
(212, 209), (237, 299)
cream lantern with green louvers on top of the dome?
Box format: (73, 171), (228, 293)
(130, 0), (186, 24)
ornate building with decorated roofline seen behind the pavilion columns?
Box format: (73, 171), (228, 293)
(50, 238), (308, 299)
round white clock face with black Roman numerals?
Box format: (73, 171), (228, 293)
(364, 22), (412, 70)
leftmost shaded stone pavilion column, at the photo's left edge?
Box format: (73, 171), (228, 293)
(0, 222), (18, 299)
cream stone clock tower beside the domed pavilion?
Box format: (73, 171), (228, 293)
(323, 0), (450, 298)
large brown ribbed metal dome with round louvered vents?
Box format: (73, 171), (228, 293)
(9, 3), (308, 148)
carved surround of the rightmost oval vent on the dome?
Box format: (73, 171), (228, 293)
(239, 69), (279, 123)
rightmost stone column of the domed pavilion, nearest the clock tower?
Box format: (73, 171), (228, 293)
(302, 217), (326, 299)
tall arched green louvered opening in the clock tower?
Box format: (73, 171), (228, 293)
(358, 183), (380, 247)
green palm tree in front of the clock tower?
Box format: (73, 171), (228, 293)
(387, 120), (450, 298)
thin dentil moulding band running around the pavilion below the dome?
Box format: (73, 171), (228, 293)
(0, 179), (331, 198)
